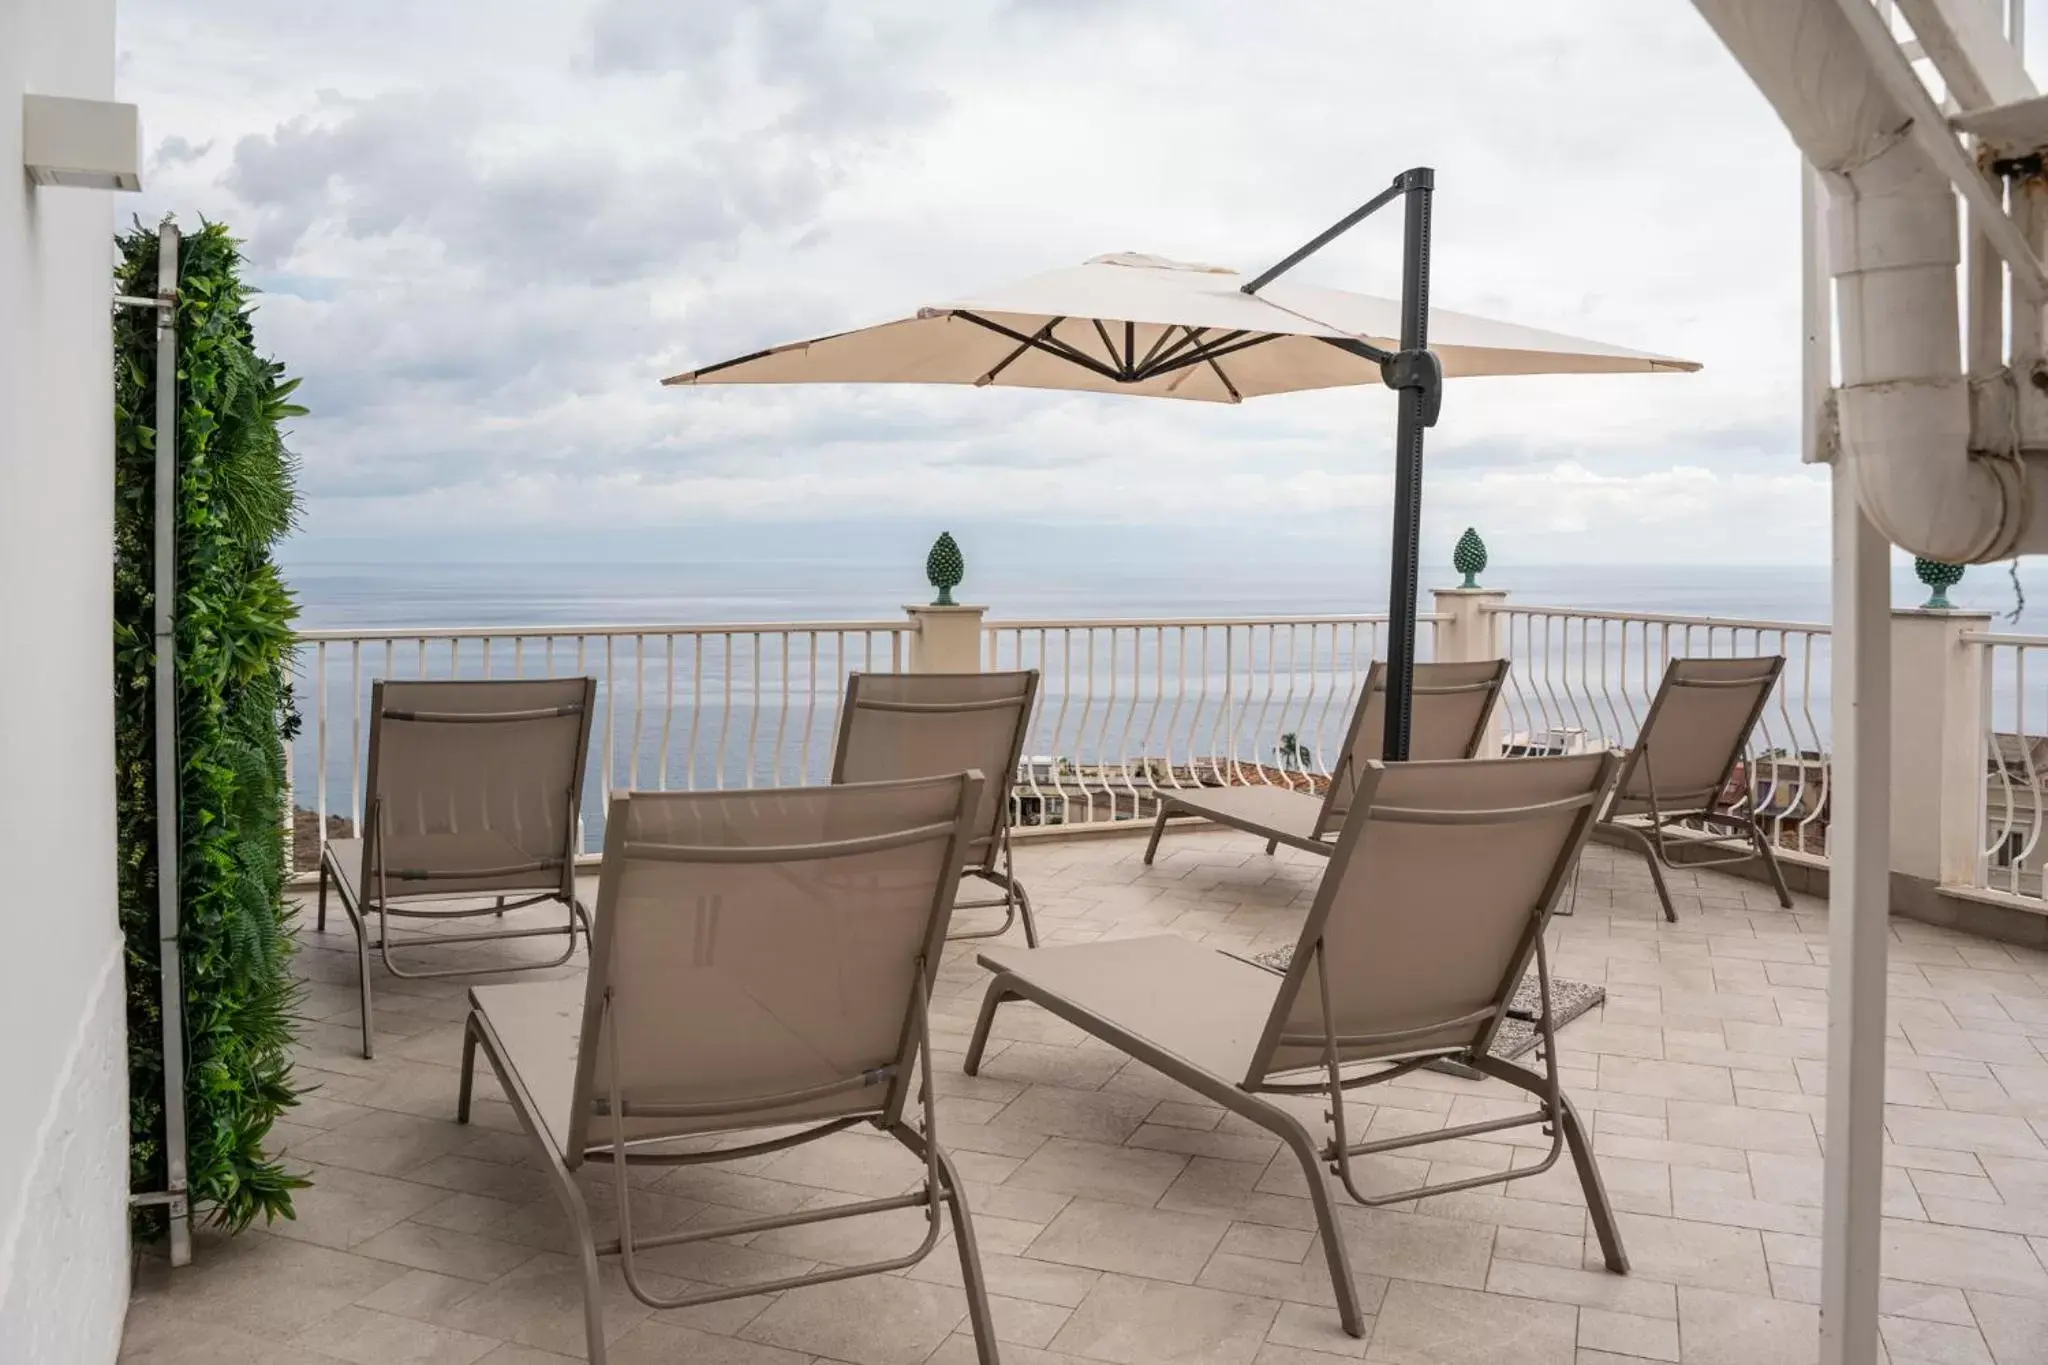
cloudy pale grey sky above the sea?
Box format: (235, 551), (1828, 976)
(121, 0), (1827, 563)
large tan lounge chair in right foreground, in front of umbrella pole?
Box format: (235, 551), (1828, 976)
(967, 753), (1628, 1336)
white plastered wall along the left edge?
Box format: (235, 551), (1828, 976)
(0, 0), (129, 1365)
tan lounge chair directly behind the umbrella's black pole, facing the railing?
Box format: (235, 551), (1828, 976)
(1145, 659), (1507, 864)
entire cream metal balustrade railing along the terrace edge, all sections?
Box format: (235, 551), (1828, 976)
(289, 606), (1843, 875)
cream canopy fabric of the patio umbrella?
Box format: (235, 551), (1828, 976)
(662, 254), (1700, 403)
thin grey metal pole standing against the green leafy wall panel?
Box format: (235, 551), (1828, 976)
(154, 217), (193, 1265)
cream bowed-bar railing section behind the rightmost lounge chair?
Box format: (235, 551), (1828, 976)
(1489, 606), (1829, 855)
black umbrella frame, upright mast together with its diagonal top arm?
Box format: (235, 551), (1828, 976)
(1243, 166), (1444, 761)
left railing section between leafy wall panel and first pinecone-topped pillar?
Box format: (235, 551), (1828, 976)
(287, 620), (911, 870)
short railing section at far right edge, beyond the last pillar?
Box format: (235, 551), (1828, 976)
(1962, 632), (2048, 905)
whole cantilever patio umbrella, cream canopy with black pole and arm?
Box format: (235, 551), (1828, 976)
(662, 168), (1700, 759)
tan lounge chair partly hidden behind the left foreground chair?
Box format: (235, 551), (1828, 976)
(831, 669), (1038, 948)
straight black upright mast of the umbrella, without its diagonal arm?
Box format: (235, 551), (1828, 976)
(1380, 166), (1436, 761)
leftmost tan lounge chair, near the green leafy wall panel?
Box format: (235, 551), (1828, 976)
(317, 677), (598, 1056)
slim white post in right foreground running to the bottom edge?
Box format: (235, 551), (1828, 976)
(1821, 419), (1892, 1365)
